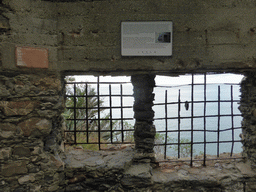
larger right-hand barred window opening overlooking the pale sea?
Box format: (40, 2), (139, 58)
(154, 74), (243, 166)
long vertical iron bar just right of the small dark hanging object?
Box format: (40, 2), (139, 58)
(190, 73), (194, 167)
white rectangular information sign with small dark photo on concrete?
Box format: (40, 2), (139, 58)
(121, 21), (173, 56)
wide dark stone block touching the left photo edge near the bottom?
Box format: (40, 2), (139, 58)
(1, 161), (28, 177)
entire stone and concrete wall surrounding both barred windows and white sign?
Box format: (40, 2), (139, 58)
(0, 0), (256, 192)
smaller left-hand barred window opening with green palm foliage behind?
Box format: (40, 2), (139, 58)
(63, 76), (134, 150)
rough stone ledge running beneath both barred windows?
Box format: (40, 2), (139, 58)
(65, 147), (256, 191)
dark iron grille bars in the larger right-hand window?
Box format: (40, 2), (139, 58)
(154, 74), (242, 166)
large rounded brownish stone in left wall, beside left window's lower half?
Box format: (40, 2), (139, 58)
(18, 118), (52, 137)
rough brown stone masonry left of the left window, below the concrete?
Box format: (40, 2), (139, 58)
(0, 73), (65, 192)
